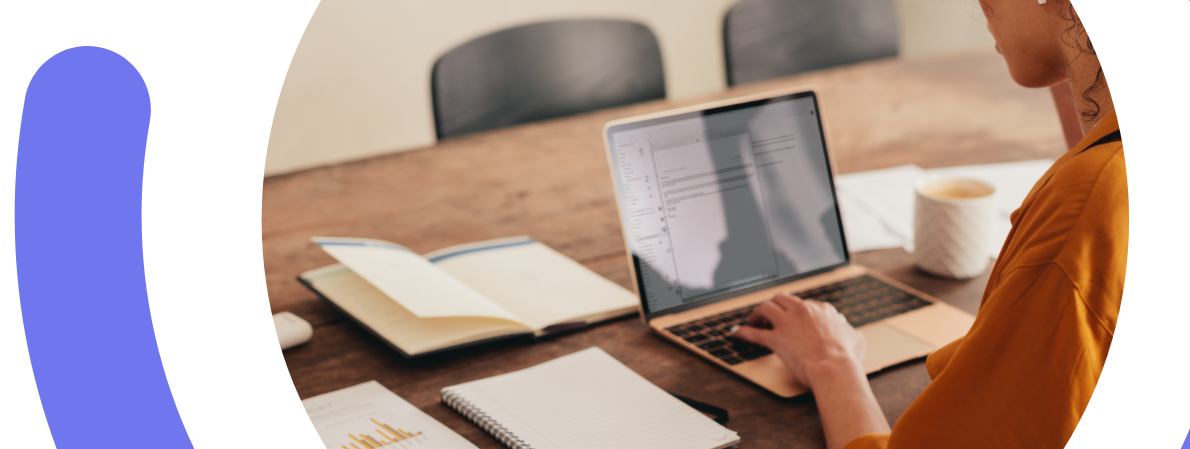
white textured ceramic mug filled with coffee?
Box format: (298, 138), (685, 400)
(913, 175), (996, 279)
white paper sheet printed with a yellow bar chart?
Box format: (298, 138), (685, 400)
(301, 380), (477, 449)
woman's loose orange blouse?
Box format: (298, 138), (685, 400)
(846, 110), (1128, 449)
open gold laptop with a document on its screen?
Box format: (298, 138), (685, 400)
(603, 88), (975, 398)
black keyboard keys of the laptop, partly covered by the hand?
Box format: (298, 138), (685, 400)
(666, 274), (929, 364)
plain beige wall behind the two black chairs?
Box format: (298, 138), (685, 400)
(264, 0), (991, 176)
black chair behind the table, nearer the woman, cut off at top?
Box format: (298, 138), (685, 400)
(724, 0), (897, 86)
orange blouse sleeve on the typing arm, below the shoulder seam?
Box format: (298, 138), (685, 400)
(880, 263), (1111, 449)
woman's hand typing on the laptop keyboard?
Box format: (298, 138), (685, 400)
(735, 294), (866, 391)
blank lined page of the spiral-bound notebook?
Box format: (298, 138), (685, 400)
(443, 348), (739, 449)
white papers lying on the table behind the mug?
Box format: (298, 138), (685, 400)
(835, 160), (1053, 257)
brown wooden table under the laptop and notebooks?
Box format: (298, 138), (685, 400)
(261, 44), (1065, 448)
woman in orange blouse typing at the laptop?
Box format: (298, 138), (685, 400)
(737, 0), (1128, 449)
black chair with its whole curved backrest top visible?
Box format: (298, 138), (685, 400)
(431, 20), (665, 139)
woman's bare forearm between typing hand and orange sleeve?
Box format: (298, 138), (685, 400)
(812, 360), (890, 449)
